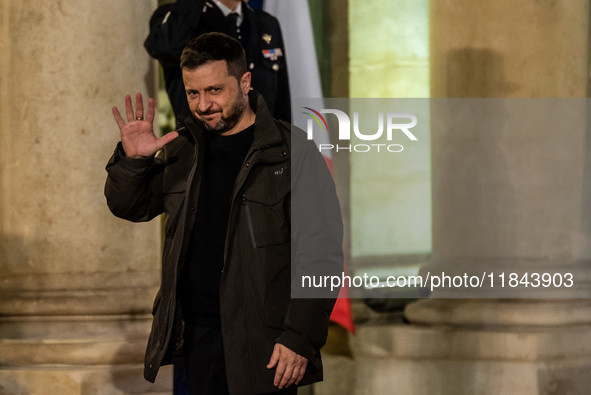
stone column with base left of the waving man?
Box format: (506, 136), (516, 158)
(0, 0), (172, 395)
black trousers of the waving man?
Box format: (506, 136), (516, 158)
(183, 325), (298, 395)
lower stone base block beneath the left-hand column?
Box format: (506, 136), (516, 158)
(0, 314), (173, 395)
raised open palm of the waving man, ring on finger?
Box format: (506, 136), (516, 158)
(113, 93), (179, 159)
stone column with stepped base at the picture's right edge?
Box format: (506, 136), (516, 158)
(357, 0), (591, 395)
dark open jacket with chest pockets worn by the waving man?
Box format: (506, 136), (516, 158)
(105, 91), (343, 394)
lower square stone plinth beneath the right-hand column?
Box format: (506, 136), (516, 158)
(354, 325), (591, 395)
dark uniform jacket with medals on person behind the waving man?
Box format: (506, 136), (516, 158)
(144, 0), (291, 122)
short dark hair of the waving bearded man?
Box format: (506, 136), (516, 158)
(181, 32), (247, 81)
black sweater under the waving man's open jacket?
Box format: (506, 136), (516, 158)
(180, 124), (254, 328)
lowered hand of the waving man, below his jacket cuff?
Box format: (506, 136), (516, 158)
(267, 343), (308, 389)
